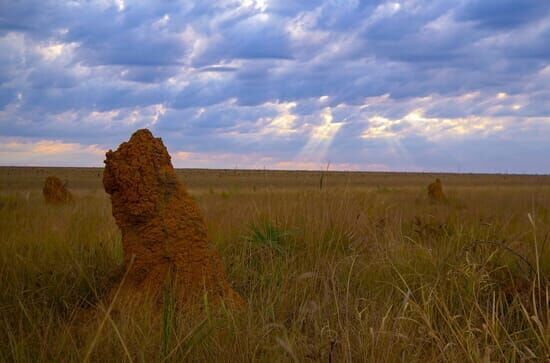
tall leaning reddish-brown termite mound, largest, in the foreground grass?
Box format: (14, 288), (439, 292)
(103, 129), (243, 305)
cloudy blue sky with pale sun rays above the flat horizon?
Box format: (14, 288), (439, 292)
(0, 0), (550, 174)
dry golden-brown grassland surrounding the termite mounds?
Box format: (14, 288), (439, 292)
(0, 168), (550, 362)
